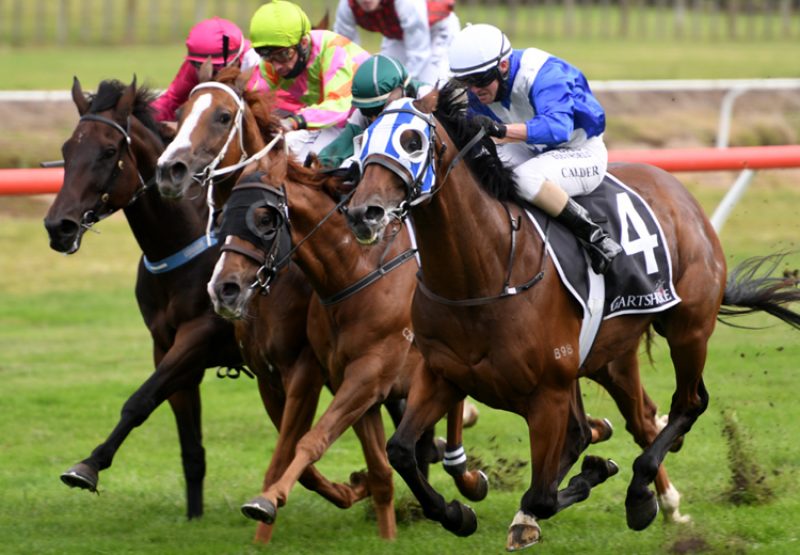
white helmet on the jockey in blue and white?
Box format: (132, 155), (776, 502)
(447, 23), (511, 78)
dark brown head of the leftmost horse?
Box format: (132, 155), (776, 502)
(44, 77), (164, 254)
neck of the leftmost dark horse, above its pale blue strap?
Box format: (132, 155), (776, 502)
(123, 130), (208, 261)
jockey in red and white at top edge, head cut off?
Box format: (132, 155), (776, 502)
(333, 0), (461, 83)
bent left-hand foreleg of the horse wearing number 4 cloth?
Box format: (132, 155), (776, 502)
(386, 366), (478, 536)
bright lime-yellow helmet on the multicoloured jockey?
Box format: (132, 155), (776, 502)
(250, 0), (311, 48)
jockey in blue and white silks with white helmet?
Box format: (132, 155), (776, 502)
(448, 24), (622, 274)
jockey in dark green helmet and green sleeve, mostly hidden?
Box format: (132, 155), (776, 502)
(319, 54), (431, 172)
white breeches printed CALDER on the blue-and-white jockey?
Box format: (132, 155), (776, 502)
(497, 133), (608, 200)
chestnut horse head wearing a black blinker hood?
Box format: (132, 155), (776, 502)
(208, 176), (292, 320)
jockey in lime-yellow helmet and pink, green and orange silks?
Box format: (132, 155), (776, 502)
(250, 0), (369, 160)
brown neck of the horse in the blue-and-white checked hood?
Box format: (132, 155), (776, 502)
(411, 162), (538, 299)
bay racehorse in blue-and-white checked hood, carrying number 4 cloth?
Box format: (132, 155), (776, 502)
(347, 86), (800, 550)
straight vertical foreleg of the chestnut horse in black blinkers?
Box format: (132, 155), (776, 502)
(353, 406), (397, 539)
